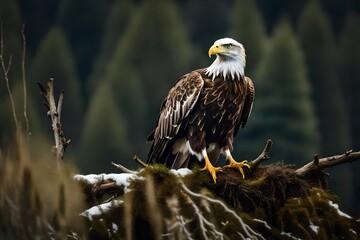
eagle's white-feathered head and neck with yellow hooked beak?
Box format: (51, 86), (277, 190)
(206, 38), (246, 80)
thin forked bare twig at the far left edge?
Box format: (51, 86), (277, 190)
(0, 22), (20, 137)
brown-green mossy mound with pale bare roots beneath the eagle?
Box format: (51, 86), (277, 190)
(79, 164), (360, 239)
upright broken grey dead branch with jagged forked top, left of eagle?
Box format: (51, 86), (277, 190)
(37, 79), (71, 164)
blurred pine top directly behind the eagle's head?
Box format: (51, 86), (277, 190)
(228, 0), (266, 76)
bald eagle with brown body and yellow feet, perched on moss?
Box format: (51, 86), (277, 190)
(147, 38), (255, 183)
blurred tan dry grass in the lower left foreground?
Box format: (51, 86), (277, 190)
(0, 136), (86, 239)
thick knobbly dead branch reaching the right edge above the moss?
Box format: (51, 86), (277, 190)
(295, 151), (360, 176)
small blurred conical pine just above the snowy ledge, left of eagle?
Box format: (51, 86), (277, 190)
(77, 82), (134, 173)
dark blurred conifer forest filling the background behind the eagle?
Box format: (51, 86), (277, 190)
(0, 0), (360, 215)
